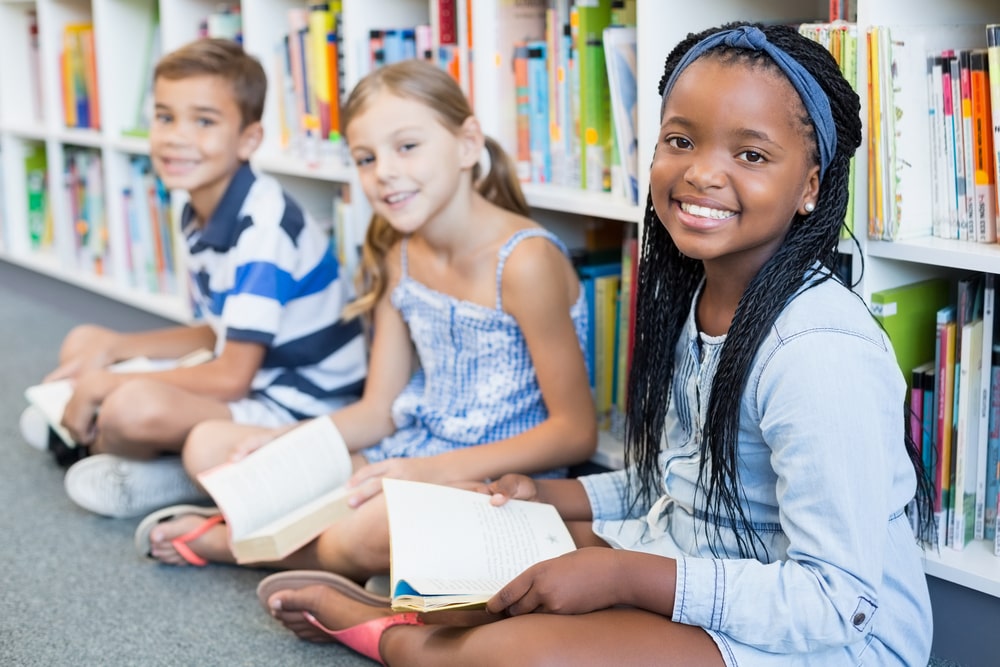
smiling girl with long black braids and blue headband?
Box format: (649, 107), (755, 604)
(262, 24), (932, 667)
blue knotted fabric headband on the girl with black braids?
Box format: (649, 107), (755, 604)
(661, 26), (837, 180)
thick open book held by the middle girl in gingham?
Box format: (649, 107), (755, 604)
(198, 416), (351, 563)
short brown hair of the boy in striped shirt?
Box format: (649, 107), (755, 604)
(153, 38), (267, 127)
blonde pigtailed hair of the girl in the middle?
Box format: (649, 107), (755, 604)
(341, 60), (528, 318)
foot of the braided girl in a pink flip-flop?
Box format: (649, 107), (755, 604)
(267, 584), (393, 643)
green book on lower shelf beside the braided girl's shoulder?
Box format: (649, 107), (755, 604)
(871, 278), (951, 392)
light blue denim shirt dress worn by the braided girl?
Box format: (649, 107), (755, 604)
(581, 272), (932, 667)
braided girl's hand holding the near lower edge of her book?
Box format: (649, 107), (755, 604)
(486, 547), (620, 616)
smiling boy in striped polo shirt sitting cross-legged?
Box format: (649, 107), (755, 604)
(50, 39), (365, 517)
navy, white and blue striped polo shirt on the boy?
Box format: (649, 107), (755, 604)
(182, 163), (366, 419)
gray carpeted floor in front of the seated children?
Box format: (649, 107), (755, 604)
(0, 262), (374, 667)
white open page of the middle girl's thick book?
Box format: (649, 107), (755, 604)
(198, 416), (352, 541)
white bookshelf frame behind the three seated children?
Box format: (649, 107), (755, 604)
(0, 0), (1000, 640)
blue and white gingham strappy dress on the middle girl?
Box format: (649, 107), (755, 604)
(362, 229), (587, 477)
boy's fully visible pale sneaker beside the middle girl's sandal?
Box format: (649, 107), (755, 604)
(64, 454), (207, 519)
